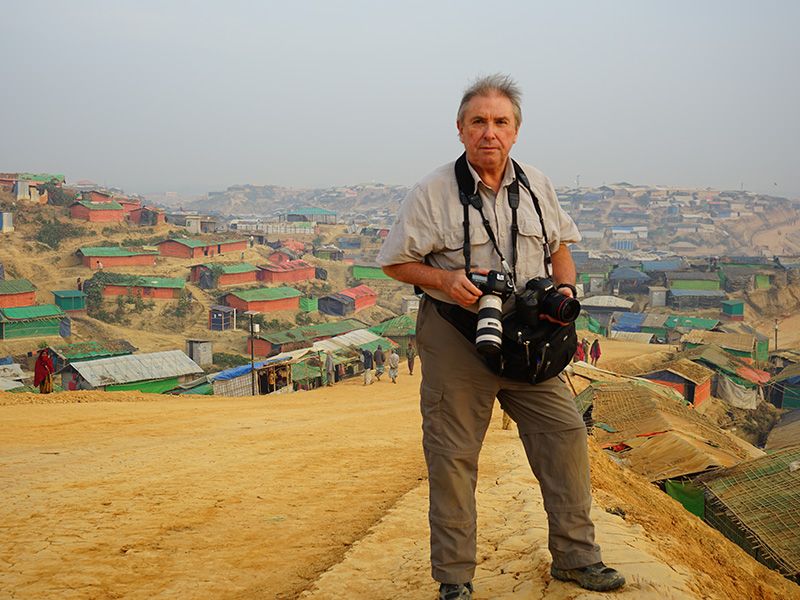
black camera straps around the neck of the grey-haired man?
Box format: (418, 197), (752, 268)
(455, 152), (552, 285)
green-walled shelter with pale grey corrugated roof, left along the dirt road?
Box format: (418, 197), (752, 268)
(62, 350), (203, 394)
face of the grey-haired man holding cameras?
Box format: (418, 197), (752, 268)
(456, 94), (519, 172)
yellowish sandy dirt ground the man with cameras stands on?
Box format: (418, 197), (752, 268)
(0, 358), (800, 600)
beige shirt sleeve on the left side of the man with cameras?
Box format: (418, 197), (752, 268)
(377, 185), (442, 267)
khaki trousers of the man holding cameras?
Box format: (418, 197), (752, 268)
(417, 299), (601, 583)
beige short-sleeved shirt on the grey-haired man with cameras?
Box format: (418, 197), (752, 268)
(378, 160), (581, 302)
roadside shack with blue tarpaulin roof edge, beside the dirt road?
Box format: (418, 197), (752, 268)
(212, 354), (295, 396)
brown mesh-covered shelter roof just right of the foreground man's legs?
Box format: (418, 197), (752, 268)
(575, 380), (763, 482)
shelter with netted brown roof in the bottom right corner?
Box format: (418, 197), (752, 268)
(697, 445), (800, 582)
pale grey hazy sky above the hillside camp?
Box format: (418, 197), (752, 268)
(0, 0), (800, 196)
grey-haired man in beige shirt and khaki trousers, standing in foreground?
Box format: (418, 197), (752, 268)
(378, 75), (625, 600)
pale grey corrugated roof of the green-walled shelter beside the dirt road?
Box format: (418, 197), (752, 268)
(70, 350), (203, 387)
